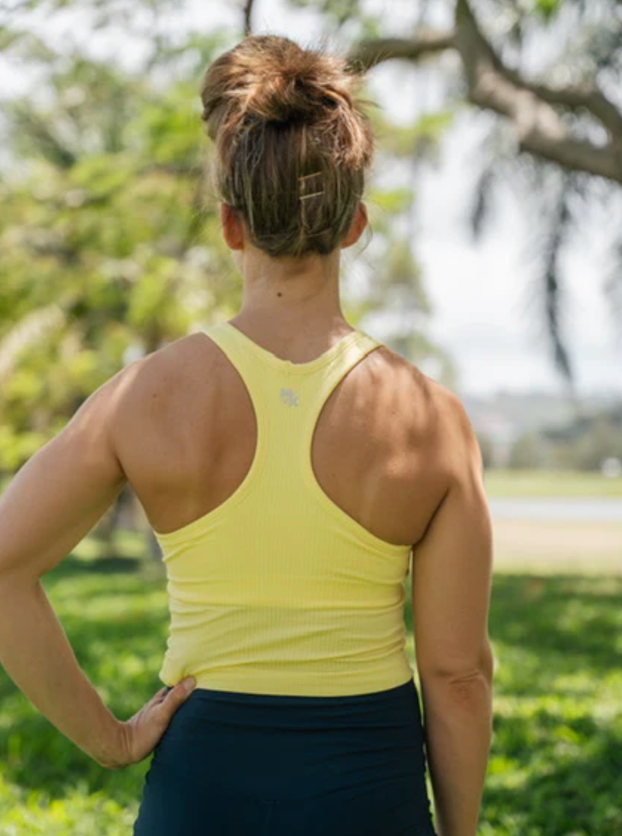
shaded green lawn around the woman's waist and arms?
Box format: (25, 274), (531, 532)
(0, 537), (622, 836)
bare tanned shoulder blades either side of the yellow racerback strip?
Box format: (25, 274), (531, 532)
(116, 320), (458, 545)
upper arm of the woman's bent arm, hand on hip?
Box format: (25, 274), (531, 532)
(0, 370), (127, 580)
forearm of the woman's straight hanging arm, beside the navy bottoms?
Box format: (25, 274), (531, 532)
(421, 676), (492, 836)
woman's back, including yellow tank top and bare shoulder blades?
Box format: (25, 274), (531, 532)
(107, 322), (458, 696)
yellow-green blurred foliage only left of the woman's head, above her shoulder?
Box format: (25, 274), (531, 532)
(0, 29), (238, 469)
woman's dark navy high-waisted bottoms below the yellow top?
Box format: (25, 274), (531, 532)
(133, 679), (437, 836)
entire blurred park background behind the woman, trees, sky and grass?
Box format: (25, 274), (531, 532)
(0, 0), (622, 836)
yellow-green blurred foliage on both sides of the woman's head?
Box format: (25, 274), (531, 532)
(0, 4), (454, 471)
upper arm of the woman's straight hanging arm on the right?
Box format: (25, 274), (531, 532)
(412, 396), (493, 680)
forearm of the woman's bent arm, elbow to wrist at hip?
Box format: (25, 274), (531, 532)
(0, 576), (122, 766)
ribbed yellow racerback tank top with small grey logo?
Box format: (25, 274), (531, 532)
(154, 321), (414, 696)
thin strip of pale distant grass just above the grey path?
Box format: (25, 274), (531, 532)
(484, 468), (622, 498)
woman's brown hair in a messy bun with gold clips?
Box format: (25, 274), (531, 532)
(201, 35), (375, 257)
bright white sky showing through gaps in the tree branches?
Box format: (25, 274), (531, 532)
(0, 0), (622, 396)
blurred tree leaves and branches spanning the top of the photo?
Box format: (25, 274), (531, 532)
(0, 0), (622, 470)
